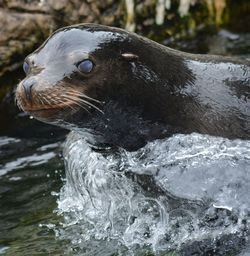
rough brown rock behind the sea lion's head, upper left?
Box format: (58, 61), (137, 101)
(0, 0), (116, 81)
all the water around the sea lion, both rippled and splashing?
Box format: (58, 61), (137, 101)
(0, 31), (250, 256)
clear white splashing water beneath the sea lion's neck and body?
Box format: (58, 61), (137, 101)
(58, 132), (250, 256)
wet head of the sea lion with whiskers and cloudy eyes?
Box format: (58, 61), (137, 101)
(16, 24), (144, 126)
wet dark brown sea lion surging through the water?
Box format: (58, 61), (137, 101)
(16, 24), (250, 150)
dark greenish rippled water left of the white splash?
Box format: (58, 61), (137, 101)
(0, 129), (66, 255)
